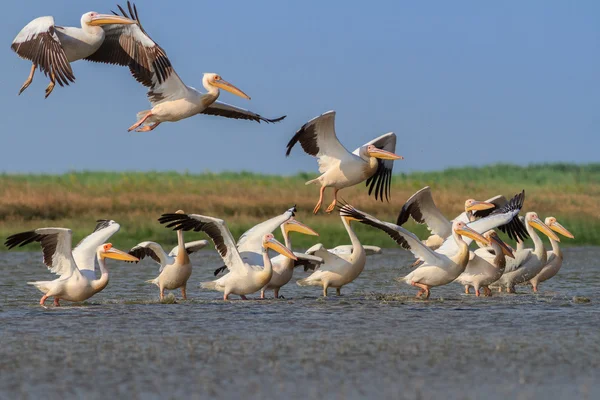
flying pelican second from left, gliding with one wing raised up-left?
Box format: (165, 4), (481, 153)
(102, 2), (285, 132)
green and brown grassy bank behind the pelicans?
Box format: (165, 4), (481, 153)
(0, 164), (600, 248)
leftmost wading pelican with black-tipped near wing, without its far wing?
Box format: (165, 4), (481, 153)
(4, 228), (139, 307)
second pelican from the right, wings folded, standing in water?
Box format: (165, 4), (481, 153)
(494, 212), (560, 293)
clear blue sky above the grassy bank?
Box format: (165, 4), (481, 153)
(0, 0), (600, 173)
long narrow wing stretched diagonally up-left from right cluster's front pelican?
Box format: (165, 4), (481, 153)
(340, 204), (442, 265)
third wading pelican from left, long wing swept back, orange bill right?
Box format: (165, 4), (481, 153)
(159, 214), (296, 300)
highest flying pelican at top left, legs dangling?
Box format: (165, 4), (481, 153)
(10, 11), (136, 97)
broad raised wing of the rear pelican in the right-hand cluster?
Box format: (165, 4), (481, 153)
(396, 186), (452, 238)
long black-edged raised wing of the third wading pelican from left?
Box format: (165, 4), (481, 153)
(158, 213), (246, 273)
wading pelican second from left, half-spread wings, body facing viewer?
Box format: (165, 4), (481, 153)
(129, 210), (208, 300)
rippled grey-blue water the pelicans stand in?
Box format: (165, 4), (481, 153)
(0, 248), (600, 399)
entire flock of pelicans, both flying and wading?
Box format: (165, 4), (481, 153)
(5, 2), (573, 306)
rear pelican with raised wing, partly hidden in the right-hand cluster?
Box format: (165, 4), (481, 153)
(396, 186), (506, 250)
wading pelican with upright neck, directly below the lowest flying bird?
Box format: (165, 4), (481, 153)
(296, 208), (367, 297)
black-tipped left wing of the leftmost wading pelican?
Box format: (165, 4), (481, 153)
(4, 228), (79, 277)
